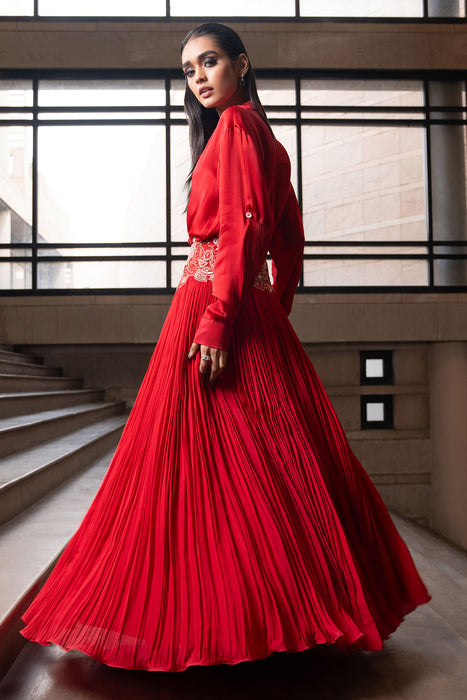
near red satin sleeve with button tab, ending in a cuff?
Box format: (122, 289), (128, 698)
(194, 115), (272, 350)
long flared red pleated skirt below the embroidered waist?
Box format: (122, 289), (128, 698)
(21, 242), (430, 671)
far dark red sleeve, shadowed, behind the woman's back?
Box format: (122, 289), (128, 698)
(270, 185), (305, 315)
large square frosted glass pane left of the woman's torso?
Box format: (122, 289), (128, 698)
(38, 125), (166, 245)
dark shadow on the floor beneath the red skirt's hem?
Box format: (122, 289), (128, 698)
(2, 645), (423, 700)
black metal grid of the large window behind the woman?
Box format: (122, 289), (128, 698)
(0, 69), (467, 296)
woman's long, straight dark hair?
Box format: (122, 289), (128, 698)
(180, 22), (272, 192)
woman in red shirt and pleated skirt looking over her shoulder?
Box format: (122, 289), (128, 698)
(22, 24), (430, 671)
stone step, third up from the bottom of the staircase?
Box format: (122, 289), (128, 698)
(0, 401), (125, 457)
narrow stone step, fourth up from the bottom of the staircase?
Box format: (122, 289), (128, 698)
(0, 389), (104, 418)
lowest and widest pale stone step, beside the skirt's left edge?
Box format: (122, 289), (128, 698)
(0, 452), (117, 680)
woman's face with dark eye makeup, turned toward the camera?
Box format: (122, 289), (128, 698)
(182, 36), (248, 114)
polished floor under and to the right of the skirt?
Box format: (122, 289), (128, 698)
(0, 516), (467, 700)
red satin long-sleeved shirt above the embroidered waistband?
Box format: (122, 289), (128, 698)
(187, 101), (304, 350)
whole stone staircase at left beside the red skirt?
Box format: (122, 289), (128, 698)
(0, 345), (127, 679)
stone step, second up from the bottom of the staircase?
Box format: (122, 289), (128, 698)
(0, 416), (126, 525)
